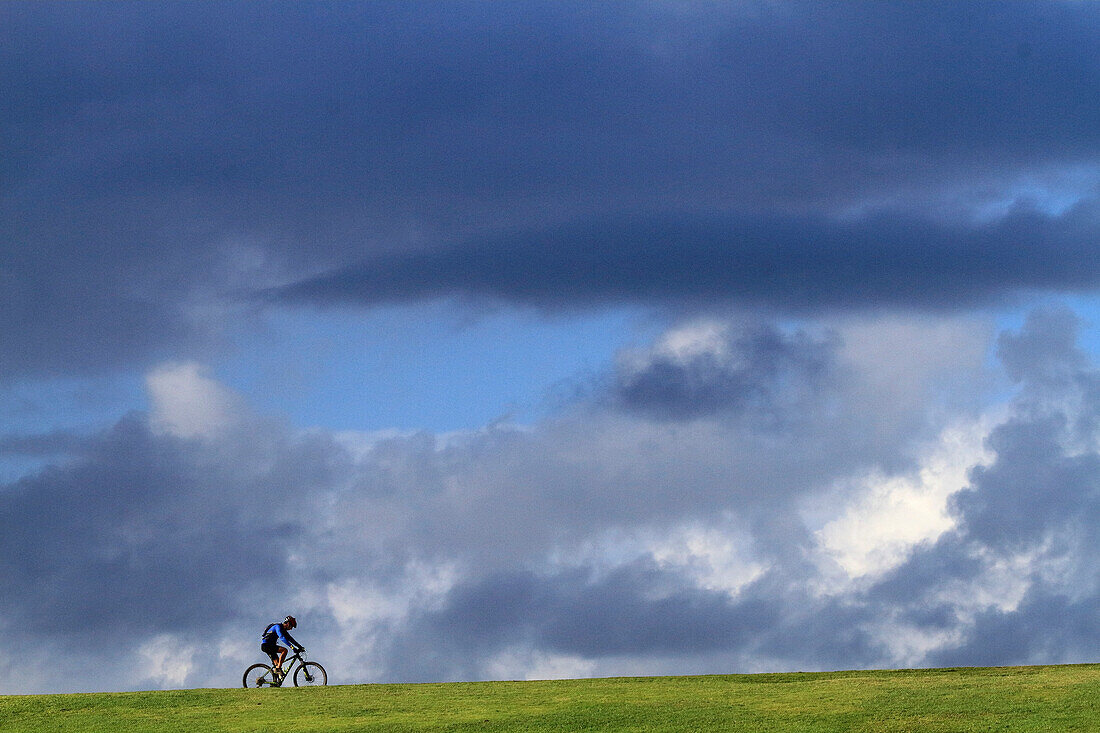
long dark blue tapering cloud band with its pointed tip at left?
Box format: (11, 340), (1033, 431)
(273, 202), (1100, 313)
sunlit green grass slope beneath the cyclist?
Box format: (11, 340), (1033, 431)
(0, 665), (1100, 733)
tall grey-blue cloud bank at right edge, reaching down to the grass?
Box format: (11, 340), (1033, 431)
(866, 310), (1100, 665)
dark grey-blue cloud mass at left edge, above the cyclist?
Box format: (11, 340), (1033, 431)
(0, 405), (358, 655)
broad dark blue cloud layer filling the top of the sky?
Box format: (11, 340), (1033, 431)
(3, 2), (1100, 195)
